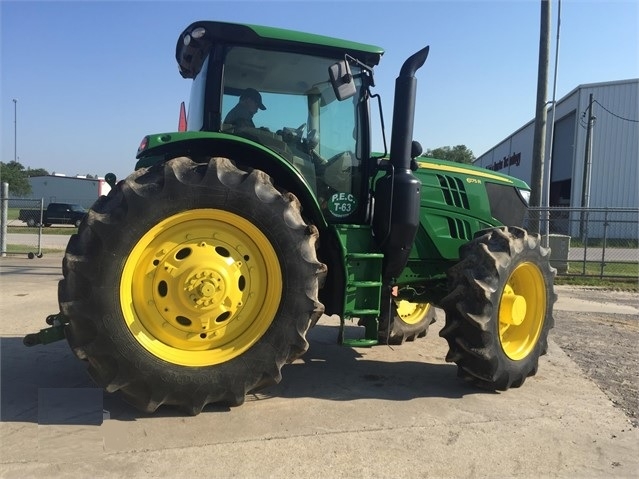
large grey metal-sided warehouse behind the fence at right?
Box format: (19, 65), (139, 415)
(475, 79), (639, 208)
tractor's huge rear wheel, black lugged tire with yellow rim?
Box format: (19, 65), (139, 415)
(58, 158), (326, 414)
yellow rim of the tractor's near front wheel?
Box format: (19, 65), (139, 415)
(499, 262), (547, 361)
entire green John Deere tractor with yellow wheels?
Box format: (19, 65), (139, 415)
(25, 21), (556, 414)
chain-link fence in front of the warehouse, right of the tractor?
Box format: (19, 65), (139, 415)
(526, 208), (639, 279)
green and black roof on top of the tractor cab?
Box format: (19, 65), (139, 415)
(175, 21), (384, 78)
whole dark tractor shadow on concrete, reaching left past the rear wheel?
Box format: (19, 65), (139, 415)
(0, 325), (489, 425)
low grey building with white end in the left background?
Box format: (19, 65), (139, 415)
(29, 175), (111, 208)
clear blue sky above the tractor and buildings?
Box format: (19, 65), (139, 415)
(0, 0), (639, 178)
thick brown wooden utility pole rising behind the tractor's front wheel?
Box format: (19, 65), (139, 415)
(530, 0), (550, 232)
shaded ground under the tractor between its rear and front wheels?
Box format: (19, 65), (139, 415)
(255, 325), (480, 401)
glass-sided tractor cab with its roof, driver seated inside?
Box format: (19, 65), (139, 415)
(176, 22), (382, 222)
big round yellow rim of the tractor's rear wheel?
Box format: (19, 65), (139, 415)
(120, 209), (282, 366)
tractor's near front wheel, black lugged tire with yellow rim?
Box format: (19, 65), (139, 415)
(440, 227), (556, 391)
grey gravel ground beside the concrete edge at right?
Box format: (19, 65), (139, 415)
(550, 287), (639, 427)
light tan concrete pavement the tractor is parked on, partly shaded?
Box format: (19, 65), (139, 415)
(0, 254), (639, 478)
